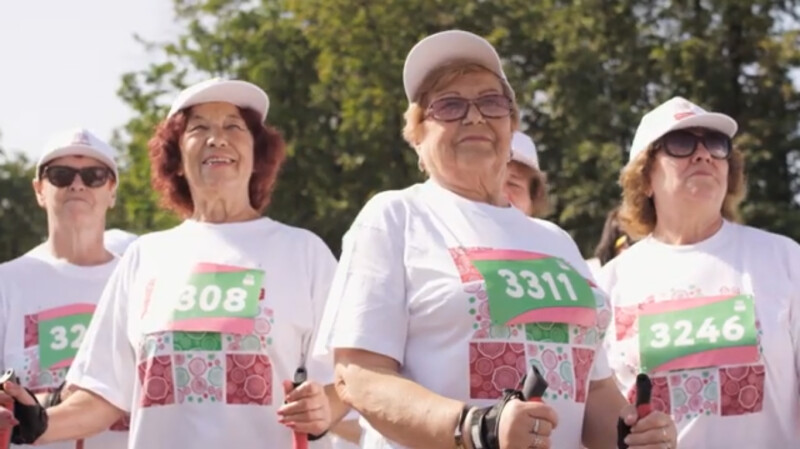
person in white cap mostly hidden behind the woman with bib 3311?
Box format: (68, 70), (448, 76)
(505, 131), (550, 217)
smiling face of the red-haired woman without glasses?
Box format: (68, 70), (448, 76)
(180, 103), (253, 200)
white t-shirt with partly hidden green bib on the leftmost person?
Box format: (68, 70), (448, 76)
(0, 244), (128, 449)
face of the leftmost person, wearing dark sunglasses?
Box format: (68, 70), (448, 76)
(33, 156), (116, 227)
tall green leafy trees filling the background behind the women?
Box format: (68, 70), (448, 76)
(1, 0), (800, 260)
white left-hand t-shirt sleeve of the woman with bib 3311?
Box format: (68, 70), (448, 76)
(315, 194), (409, 364)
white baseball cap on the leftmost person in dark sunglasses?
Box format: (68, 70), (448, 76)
(36, 128), (119, 180)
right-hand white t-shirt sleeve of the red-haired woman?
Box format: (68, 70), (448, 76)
(307, 235), (336, 384)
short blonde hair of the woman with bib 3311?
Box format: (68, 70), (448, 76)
(403, 61), (519, 146)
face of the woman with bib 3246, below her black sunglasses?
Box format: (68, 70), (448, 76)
(650, 129), (729, 213)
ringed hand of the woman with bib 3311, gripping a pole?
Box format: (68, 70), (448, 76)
(497, 399), (558, 449)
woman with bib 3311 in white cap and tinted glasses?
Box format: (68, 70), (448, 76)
(316, 30), (674, 449)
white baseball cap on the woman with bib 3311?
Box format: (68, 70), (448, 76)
(403, 30), (513, 103)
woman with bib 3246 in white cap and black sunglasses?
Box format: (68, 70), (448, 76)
(600, 98), (800, 449)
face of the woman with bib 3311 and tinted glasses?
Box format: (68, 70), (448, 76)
(417, 71), (513, 194)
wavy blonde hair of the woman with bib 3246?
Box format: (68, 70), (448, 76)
(618, 144), (747, 238)
